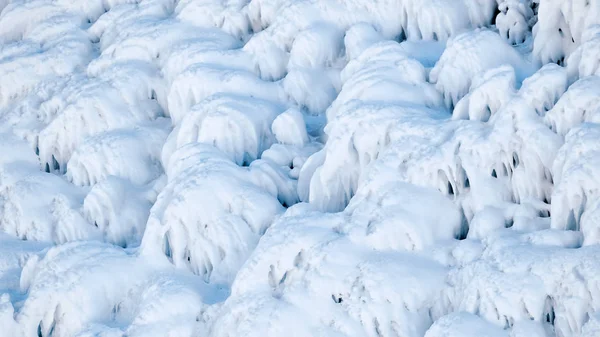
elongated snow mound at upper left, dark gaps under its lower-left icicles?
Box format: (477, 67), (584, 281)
(36, 65), (162, 172)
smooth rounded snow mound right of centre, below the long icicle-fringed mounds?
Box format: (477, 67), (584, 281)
(344, 178), (466, 250)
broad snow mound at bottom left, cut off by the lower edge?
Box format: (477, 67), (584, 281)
(14, 242), (227, 336)
